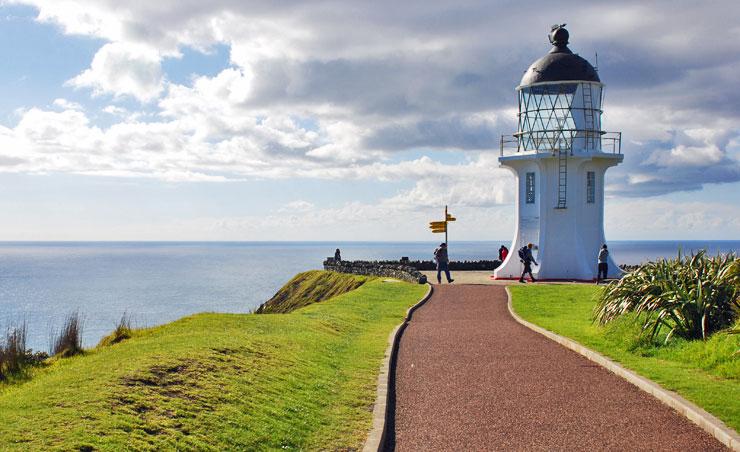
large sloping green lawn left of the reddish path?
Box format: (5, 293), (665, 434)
(0, 279), (427, 450)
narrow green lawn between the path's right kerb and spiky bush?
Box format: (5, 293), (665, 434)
(511, 284), (740, 431)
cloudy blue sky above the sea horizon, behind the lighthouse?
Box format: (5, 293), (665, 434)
(0, 0), (740, 241)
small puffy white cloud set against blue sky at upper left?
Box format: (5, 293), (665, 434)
(67, 42), (164, 102)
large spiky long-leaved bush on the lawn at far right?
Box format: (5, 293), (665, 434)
(594, 251), (740, 342)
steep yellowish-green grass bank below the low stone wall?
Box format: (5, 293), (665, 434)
(256, 270), (372, 314)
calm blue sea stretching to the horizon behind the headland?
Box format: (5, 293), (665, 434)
(0, 241), (740, 350)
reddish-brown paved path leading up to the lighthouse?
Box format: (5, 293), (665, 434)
(390, 285), (724, 451)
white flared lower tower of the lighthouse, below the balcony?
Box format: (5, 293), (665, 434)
(494, 152), (623, 281)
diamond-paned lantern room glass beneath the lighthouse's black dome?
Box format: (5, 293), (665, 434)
(517, 82), (603, 153)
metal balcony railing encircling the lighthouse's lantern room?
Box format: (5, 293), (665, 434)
(500, 129), (622, 157)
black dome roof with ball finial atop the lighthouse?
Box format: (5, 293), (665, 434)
(519, 25), (601, 86)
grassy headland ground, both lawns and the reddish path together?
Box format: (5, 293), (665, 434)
(0, 264), (740, 450)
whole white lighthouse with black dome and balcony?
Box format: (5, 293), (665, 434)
(494, 25), (624, 281)
